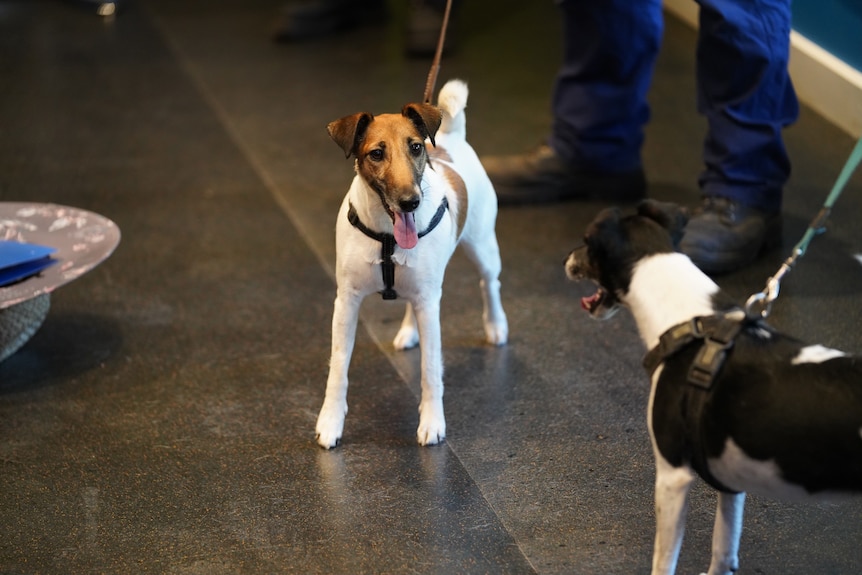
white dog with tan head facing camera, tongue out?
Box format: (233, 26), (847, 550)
(316, 80), (508, 449)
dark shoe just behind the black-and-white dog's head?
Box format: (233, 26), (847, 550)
(679, 196), (781, 274)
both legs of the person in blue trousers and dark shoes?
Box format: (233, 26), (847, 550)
(482, 0), (798, 272)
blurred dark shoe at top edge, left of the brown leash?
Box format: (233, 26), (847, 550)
(273, 0), (386, 42)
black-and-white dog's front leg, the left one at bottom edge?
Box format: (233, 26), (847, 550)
(652, 462), (694, 575)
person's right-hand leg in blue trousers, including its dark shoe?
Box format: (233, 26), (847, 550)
(680, 0), (799, 273)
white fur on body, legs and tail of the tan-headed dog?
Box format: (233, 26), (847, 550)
(316, 80), (508, 449)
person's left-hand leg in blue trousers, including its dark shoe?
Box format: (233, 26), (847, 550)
(482, 0), (663, 204)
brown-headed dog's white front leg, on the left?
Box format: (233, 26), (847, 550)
(316, 288), (362, 449)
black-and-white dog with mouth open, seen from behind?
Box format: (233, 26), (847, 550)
(566, 200), (862, 575)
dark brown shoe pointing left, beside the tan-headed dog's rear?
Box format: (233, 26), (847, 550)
(481, 145), (646, 205)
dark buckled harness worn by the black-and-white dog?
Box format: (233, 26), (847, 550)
(643, 314), (769, 493)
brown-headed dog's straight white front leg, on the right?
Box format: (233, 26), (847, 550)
(413, 289), (446, 445)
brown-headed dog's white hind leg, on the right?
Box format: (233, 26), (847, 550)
(462, 234), (509, 345)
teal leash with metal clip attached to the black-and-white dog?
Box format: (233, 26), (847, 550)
(745, 138), (862, 319)
